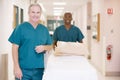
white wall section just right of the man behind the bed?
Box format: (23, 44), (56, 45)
(73, 4), (87, 45)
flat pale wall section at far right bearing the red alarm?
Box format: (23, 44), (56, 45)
(104, 0), (120, 72)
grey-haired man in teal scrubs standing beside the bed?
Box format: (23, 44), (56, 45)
(8, 4), (52, 80)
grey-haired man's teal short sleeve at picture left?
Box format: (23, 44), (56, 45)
(8, 26), (21, 45)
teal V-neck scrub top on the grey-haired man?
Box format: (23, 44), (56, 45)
(8, 22), (52, 69)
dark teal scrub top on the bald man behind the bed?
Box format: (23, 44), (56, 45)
(53, 25), (84, 42)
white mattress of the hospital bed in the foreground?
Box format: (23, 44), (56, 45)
(43, 51), (98, 80)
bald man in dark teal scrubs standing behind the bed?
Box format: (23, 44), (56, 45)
(53, 12), (84, 47)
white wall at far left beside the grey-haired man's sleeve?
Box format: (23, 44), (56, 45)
(0, 0), (13, 80)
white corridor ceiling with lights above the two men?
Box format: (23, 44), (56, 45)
(34, 0), (90, 16)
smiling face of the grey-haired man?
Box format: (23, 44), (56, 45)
(29, 6), (41, 22)
